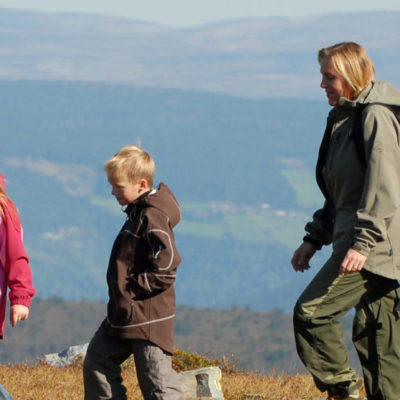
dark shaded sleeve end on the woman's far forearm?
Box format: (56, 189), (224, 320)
(303, 201), (335, 250)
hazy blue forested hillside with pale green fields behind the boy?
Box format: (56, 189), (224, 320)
(0, 81), (327, 310)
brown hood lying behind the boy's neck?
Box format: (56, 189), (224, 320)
(125, 183), (181, 227)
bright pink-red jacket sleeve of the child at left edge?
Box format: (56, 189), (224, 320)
(5, 208), (36, 307)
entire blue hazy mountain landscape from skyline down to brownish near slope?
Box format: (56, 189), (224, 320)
(0, 9), (400, 311)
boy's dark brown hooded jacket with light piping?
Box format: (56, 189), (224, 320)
(107, 183), (181, 353)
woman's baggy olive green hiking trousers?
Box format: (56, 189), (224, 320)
(293, 255), (400, 400)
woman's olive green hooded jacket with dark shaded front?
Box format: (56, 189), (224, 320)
(305, 81), (400, 279)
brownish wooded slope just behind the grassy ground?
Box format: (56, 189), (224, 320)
(0, 299), (358, 373)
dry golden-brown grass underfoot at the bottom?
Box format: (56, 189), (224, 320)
(0, 364), (366, 400)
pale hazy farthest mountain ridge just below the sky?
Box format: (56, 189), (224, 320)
(0, 8), (400, 98)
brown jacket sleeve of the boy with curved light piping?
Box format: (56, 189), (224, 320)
(131, 209), (181, 297)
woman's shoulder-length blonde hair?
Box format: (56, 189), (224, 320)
(318, 42), (375, 99)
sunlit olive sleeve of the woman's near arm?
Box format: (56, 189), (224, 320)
(352, 105), (400, 256)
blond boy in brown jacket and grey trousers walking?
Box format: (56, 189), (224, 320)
(83, 146), (182, 400)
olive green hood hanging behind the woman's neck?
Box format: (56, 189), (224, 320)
(339, 80), (400, 107)
